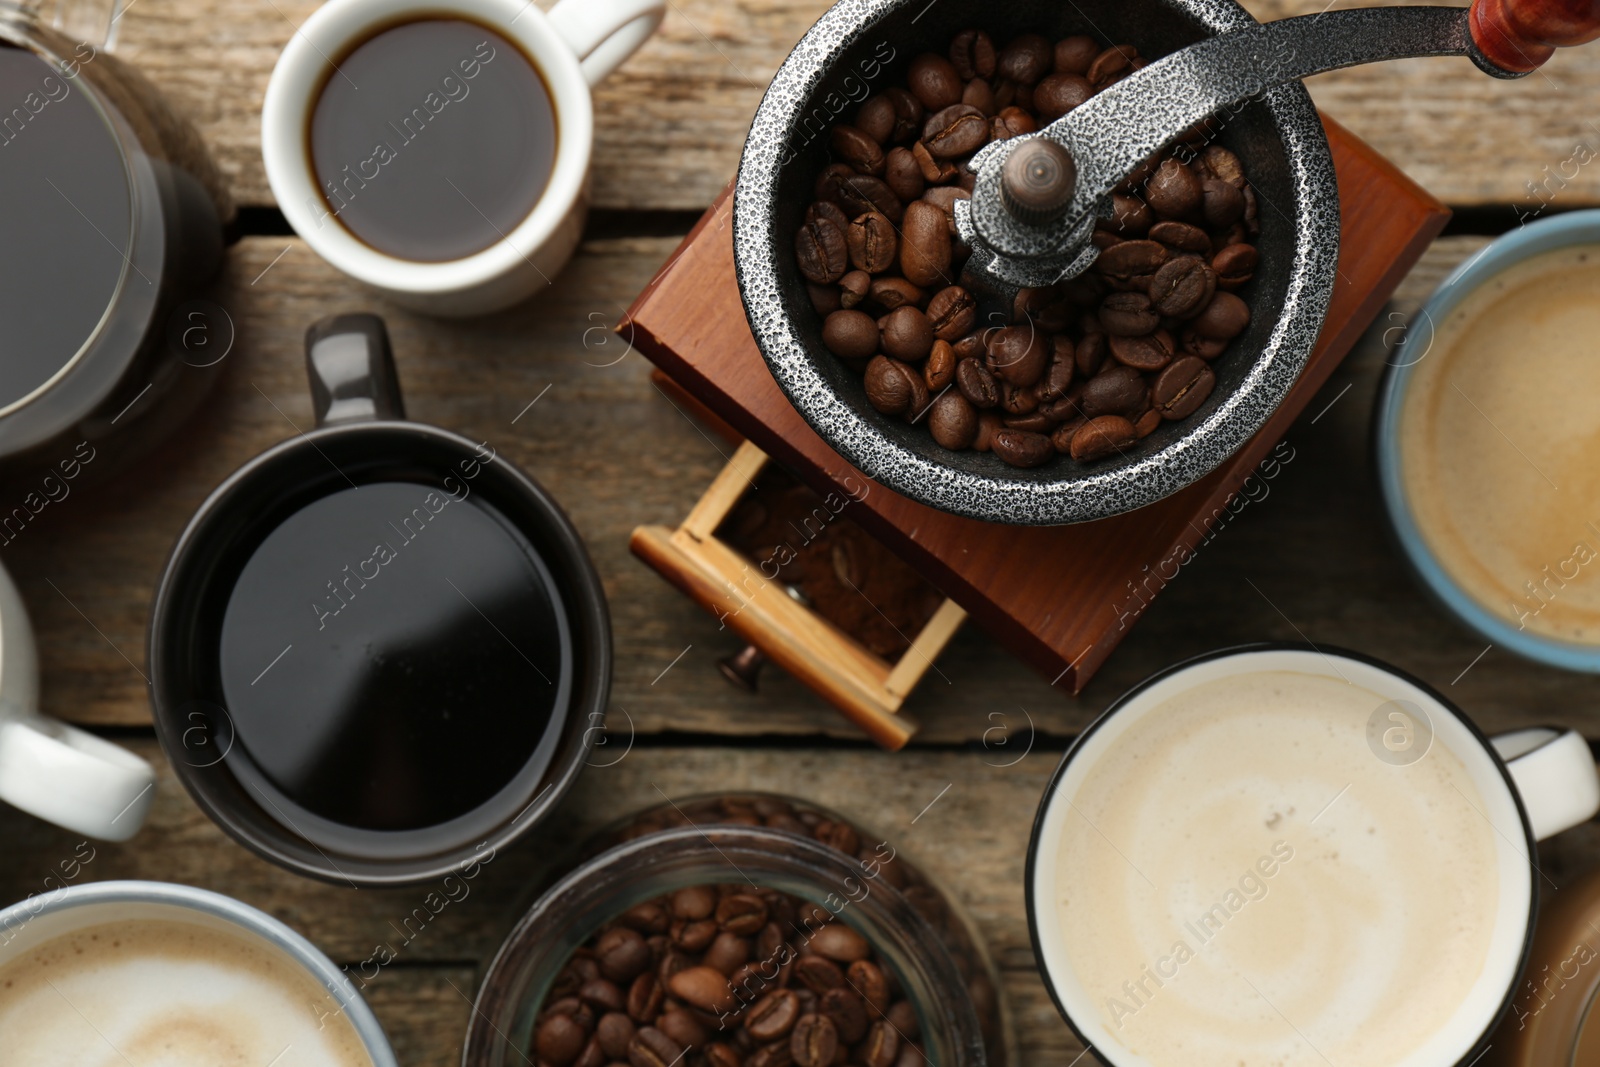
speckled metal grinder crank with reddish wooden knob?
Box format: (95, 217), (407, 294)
(957, 0), (1600, 285)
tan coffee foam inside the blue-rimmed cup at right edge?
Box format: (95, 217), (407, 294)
(1400, 245), (1600, 645)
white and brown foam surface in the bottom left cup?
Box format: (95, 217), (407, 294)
(0, 920), (371, 1067)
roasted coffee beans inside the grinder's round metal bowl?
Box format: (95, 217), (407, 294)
(795, 29), (1261, 467)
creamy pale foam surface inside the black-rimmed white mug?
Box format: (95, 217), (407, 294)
(1046, 672), (1499, 1067)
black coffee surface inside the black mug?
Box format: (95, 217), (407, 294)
(221, 472), (573, 841)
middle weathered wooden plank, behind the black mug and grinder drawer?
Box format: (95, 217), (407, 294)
(9, 231), (1600, 744)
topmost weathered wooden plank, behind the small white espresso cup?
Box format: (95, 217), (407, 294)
(120, 0), (1600, 212)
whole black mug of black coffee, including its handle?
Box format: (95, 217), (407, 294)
(149, 315), (611, 885)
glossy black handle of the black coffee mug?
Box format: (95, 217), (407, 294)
(306, 312), (405, 426)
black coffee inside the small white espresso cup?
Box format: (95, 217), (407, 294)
(307, 18), (557, 262)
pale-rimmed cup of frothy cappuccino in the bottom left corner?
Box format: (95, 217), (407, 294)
(0, 881), (397, 1067)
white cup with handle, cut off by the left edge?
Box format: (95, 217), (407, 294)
(0, 556), (155, 841)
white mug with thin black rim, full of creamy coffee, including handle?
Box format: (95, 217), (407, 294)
(1027, 646), (1600, 1067)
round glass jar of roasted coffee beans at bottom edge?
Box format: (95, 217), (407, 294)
(462, 793), (1014, 1067)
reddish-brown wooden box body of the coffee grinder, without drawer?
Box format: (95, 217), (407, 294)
(618, 117), (1450, 693)
